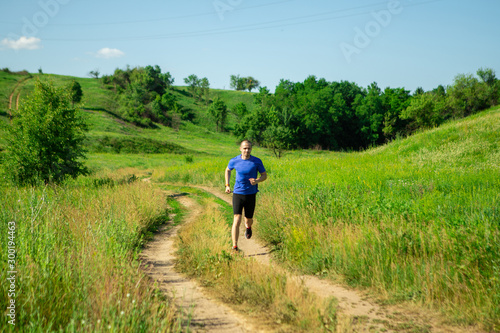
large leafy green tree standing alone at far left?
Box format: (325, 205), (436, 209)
(5, 80), (88, 185)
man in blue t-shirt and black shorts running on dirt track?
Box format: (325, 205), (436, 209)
(225, 140), (267, 251)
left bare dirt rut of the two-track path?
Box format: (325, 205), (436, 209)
(141, 196), (258, 332)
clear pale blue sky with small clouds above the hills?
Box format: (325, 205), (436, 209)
(0, 0), (500, 91)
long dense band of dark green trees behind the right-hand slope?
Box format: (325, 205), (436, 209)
(234, 68), (500, 156)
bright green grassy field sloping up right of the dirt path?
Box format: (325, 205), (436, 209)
(153, 109), (500, 330)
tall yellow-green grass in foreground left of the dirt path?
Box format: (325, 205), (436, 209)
(0, 170), (177, 332)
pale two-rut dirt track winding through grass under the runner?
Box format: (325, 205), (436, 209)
(139, 182), (481, 333)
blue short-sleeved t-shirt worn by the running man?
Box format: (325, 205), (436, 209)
(227, 155), (266, 194)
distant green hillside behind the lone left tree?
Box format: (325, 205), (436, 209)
(0, 71), (253, 153)
